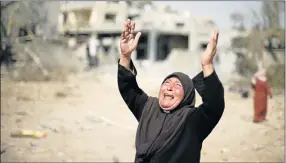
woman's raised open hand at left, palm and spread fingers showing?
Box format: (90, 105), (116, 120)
(120, 19), (141, 59)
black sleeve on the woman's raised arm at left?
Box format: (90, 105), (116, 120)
(117, 61), (148, 121)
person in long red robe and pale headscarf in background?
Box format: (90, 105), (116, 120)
(251, 69), (272, 123)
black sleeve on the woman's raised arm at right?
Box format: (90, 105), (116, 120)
(193, 71), (225, 141)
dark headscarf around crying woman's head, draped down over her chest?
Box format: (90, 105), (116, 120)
(135, 72), (195, 162)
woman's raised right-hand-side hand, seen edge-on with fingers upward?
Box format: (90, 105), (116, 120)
(201, 30), (219, 66)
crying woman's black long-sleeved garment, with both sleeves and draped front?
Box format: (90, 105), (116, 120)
(118, 62), (224, 163)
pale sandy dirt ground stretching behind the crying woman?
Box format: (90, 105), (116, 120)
(1, 66), (285, 162)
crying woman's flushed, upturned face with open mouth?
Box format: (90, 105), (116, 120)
(159, 77), (184, 110)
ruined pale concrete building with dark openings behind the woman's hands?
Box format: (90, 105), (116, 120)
(58, 1), (215, 61)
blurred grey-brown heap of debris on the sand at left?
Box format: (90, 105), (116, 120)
(1, 38), (81, 81)
